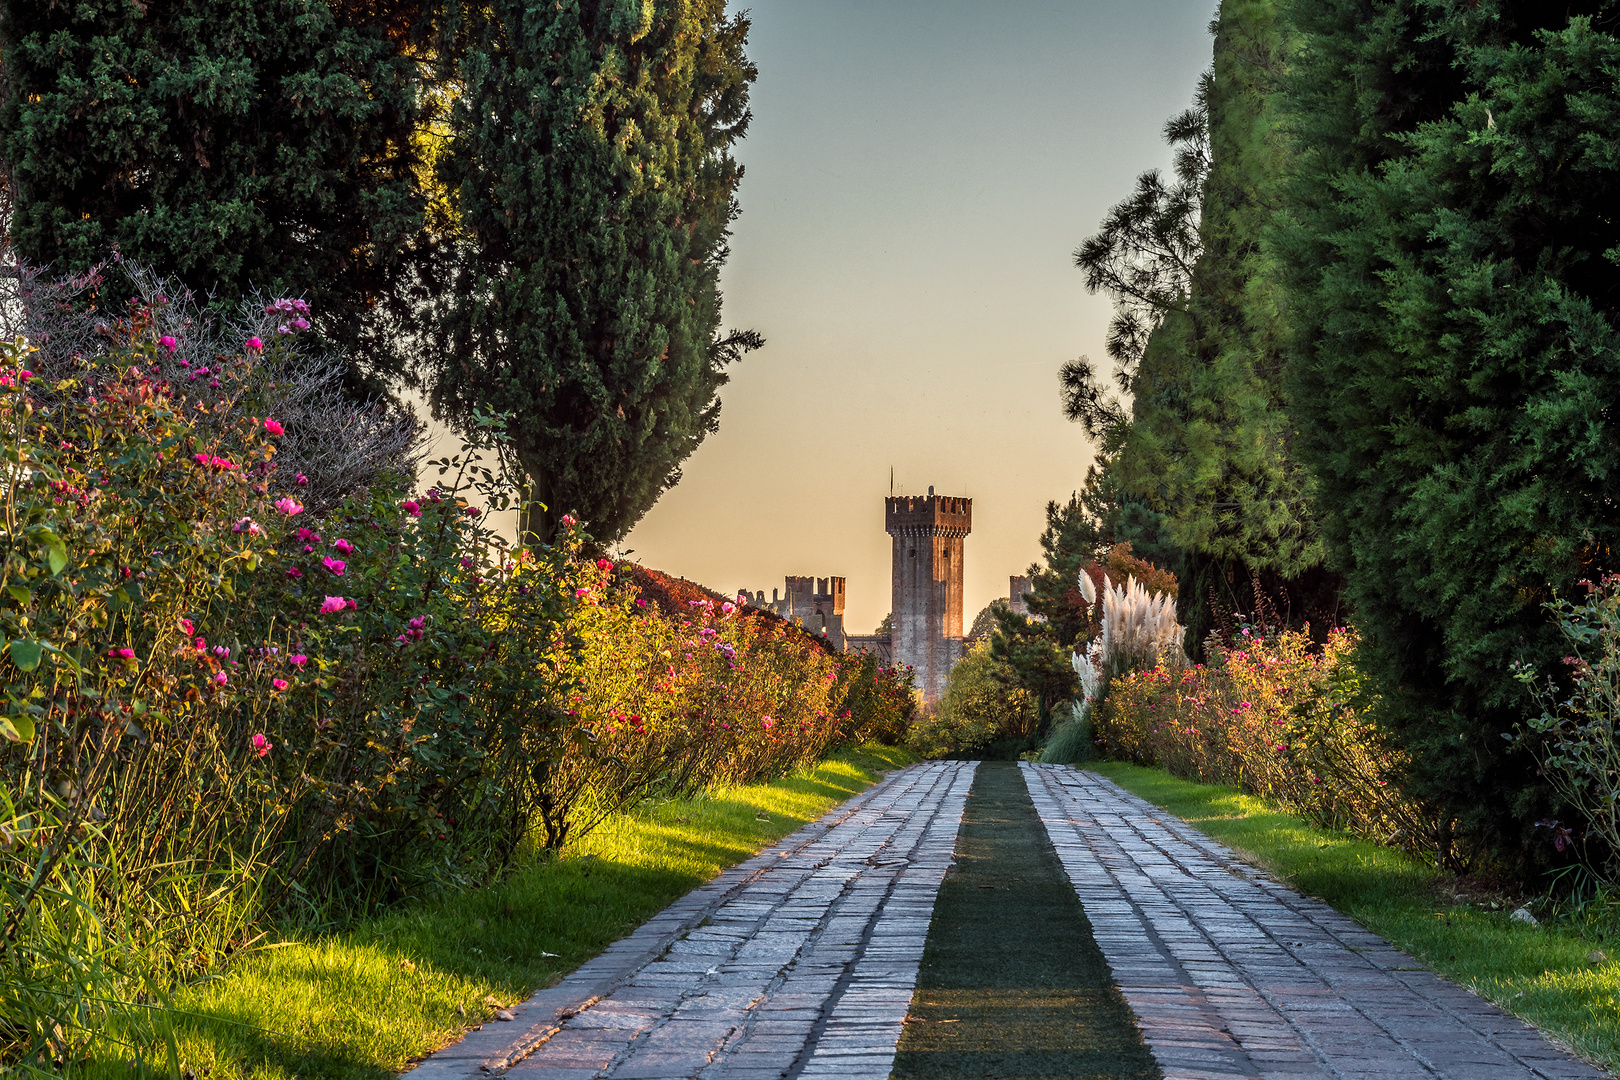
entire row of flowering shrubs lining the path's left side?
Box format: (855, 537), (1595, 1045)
(0, 314), (910, 1072)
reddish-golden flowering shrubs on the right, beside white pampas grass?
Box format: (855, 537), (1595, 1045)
(1092, 627), (1439, 853)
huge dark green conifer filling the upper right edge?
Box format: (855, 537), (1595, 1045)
(1277, 0), (1620, 858)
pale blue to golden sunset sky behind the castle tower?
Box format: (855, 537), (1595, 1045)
(437, 0), (1215, 633)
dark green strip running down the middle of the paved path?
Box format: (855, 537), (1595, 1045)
(893, 761), (1160, 1080)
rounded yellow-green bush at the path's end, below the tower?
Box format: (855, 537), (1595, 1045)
(907, 641), (1040, 758)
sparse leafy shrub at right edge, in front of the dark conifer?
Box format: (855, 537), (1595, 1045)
(1505, 573), (1620, 886)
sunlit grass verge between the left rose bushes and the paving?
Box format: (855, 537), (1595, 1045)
(136, 746), (914, 1080)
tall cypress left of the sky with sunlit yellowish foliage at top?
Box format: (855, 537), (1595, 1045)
(429, 0), (761, 541)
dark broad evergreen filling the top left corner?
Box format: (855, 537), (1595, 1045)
(0, 0), (431, 386)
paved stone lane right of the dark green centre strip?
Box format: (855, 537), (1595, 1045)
(1022, 764), (1604, 1080)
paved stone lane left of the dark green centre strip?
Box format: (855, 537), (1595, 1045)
(411, 761), (975, 1080)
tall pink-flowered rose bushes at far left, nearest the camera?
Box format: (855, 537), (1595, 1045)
(0, 335), (577, 1067)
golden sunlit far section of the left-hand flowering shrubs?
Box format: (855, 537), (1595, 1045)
(536, 579), (912, 845)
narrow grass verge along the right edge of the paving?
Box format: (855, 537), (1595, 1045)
(1087, 763), (1620, 1072)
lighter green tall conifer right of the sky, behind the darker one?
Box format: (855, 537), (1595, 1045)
(1066, 0), (1338, 651)
